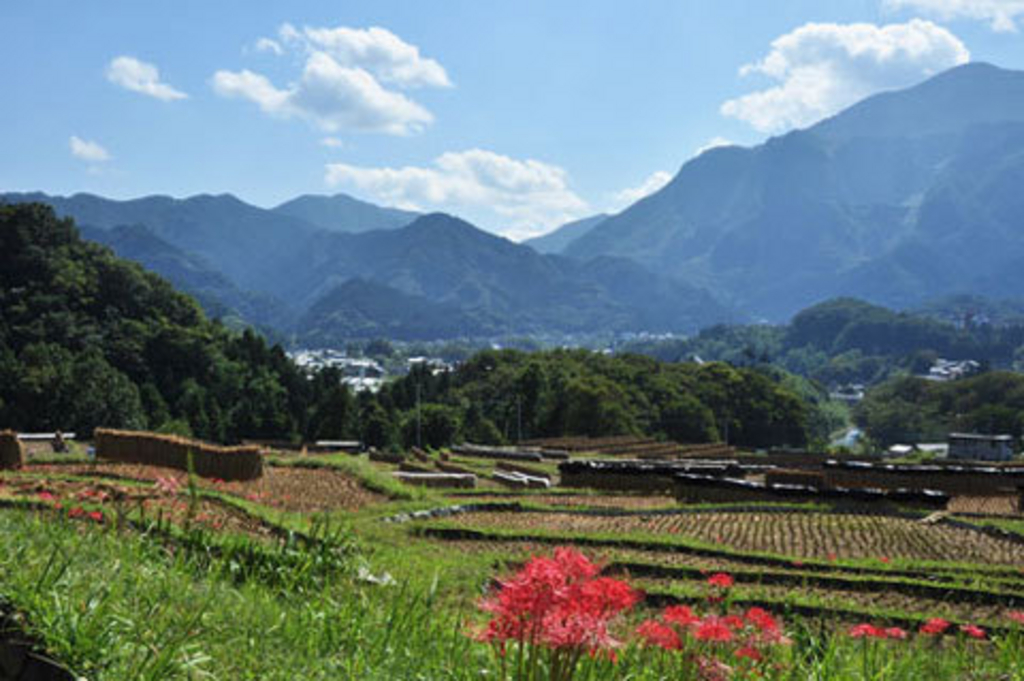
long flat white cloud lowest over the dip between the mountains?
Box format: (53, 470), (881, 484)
(325, 148), (589, 240)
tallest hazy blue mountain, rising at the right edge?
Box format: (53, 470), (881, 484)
(565, 65), (1024, 318)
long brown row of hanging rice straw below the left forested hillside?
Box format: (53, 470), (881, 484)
(95, 428), (263, 480)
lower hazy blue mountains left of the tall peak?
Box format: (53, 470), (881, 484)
(0, 194), (735, 344)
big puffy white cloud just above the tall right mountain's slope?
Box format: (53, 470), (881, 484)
(721, 18), (971, 132)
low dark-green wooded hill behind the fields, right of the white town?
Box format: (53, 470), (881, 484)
(372, 350), (812, 446)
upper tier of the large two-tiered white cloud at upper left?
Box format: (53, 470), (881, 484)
(274, 24), (452, 87)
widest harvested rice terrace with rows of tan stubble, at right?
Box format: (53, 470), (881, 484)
(434, 512), (1024, 566)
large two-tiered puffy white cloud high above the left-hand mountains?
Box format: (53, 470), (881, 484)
(210, 24), (451, 135)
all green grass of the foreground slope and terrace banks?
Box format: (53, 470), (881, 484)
(6, 455), (1024, 681)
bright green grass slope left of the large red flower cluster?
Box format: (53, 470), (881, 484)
(0, 511), (482, 679)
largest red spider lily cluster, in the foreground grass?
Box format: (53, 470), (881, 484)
(477, 548), (640, 653)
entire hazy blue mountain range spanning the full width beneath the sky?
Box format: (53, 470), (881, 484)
(6, 63), (1024, 343)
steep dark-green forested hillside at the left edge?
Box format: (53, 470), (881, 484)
(0, 204), (318, 440)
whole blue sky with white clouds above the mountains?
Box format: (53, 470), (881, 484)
(0, 0), (1024, 239)
